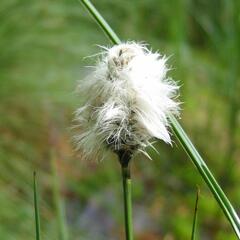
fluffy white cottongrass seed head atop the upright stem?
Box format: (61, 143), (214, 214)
(75, 42), (179, 159)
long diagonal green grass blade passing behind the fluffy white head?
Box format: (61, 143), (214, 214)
(81, 0), (240, 236)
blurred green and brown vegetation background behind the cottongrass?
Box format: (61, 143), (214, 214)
(0, 0), (240, 240)
